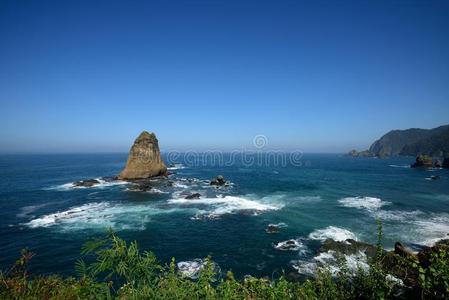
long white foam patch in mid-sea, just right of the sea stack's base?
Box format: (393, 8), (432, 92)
(168, 196), (282, 218)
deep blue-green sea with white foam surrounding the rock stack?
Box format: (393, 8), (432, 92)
(0, 153), (449, 277)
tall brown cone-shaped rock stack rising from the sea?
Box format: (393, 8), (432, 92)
(118, 131), (167, 180)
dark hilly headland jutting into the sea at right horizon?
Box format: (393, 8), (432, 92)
(349, 125), (449, 157)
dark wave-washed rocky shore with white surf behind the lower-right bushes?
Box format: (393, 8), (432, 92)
(285, 239), (449, 295)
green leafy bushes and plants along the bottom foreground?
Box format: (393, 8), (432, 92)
(0, 224), (449, 300)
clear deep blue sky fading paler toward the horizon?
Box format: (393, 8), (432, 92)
(0, 0), (449, 152)
